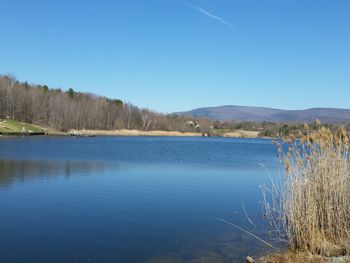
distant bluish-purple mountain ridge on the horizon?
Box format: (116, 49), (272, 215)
(174, 105), (350, 123)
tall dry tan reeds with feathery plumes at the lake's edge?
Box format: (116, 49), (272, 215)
(263, 123), (350, 256)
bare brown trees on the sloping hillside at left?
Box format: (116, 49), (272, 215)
(0, 75), (210, 132)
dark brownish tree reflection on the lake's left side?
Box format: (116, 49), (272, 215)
(0, 160), (115, 187)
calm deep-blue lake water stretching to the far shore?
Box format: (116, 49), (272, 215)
(0, 137), (278, 263)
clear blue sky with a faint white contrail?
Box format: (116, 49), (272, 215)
(0, 0), (350, 112)
